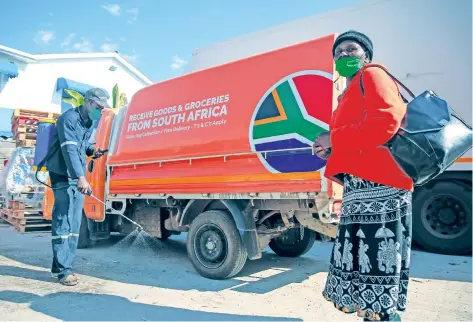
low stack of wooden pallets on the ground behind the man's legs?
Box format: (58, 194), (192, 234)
(0, 191), (51, 233)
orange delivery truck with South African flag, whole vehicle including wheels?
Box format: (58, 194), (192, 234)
(43, 34), (343, 279)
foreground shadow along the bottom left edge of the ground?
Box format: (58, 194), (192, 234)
(0, 291), (300, 321)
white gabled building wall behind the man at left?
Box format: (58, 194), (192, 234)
(0, 54), (147, 112)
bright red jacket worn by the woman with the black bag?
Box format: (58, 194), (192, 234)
(325, 65), (414, 191)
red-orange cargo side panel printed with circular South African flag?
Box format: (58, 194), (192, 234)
(109, 35), (338, 194)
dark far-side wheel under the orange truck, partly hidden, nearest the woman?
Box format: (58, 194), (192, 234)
(269, 227), (317, 257)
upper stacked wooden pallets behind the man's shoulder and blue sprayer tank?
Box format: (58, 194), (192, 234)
(11, 108), (60, 147)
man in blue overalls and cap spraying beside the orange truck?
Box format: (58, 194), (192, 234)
(47, 88), (110, 286)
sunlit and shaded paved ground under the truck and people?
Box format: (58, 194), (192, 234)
(0, 224), (472, 321)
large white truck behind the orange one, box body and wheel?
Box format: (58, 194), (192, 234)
(189, 0), (473, 254)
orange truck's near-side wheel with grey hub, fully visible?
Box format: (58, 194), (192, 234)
(187, 210), (248, 280)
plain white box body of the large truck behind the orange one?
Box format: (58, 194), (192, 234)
(188, 0), (473, 171)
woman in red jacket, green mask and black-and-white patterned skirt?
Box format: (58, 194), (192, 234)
(314, 31), (413, 321)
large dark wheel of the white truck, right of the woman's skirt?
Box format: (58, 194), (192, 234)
(412, 181), (472, 255)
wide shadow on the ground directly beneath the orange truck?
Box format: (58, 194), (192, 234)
(0, 225), (472, 294)
